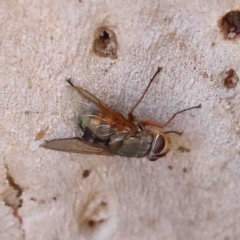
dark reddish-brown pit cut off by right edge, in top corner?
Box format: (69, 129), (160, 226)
(220, 10), (240, 39)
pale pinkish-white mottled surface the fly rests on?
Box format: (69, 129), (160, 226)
(0, 0), (240, 240)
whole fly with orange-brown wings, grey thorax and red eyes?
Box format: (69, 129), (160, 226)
(41, 68), (201, 161)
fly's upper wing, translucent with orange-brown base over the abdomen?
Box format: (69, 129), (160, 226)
(68, 85), (138, 140)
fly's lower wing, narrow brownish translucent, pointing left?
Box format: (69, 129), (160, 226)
(40, 138), (114, 155)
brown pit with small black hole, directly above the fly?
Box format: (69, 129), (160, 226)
(93, 27), (118, 59)
